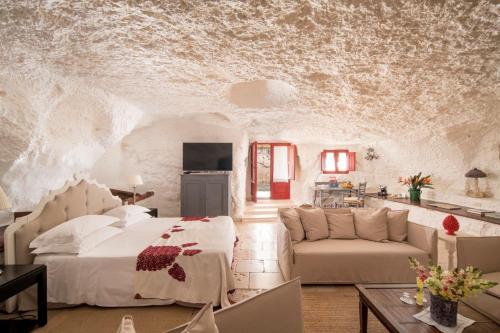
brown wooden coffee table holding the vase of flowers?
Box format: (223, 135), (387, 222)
(356, 284), (500, 333)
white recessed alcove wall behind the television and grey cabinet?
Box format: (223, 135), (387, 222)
(91, 114), (249, 218)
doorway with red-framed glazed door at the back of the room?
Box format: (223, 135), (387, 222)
(250, 142), (297, 202)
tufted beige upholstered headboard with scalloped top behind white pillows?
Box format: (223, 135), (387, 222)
(4, 179), (122, 264)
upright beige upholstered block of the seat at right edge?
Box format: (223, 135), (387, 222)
(457, 236), (500, 273)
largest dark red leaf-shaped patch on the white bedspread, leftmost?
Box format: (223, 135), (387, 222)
(136, 246), (182, 271)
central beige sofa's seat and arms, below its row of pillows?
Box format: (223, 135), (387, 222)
(278, 209), (437, 284)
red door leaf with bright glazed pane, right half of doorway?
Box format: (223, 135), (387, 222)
(271, 143), (296, 200)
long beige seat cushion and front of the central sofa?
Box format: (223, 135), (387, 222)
(292, 239), (429, 284)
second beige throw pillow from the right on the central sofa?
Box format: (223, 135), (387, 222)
(353, 207), (389, 242)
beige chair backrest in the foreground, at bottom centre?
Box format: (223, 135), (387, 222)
(165, 278), (304, 333)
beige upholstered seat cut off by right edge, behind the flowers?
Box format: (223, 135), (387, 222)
(457, 236), (500, 325)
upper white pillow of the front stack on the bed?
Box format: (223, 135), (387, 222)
(30, 215), (119, 248)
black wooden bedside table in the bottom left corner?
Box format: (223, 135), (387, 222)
(0, 265), (47, 331)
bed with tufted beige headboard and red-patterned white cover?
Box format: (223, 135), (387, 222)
(6, 179), (236, 310)
